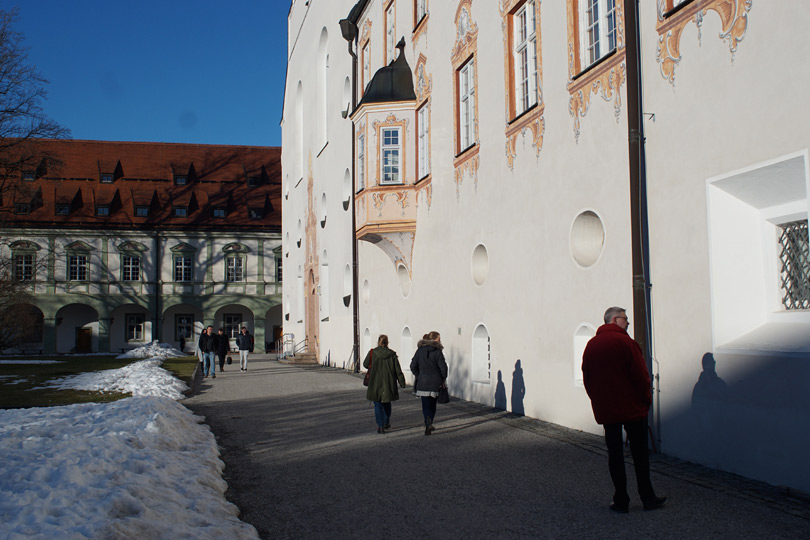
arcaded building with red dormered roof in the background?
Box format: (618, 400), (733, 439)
(0, 140), (281, 353)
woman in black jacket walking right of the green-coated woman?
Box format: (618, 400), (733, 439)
(411, 331), (447, 435)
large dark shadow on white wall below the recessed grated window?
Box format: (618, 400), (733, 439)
(661, 352), (810, 492)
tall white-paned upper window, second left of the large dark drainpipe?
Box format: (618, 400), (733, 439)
(512, 0), (537, 116)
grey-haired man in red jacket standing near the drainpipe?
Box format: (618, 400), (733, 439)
(582, 307), (667, 514)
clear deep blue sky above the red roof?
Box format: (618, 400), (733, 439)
(9, 0), (290, 146)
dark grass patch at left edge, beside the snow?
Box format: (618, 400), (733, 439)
(0, 356), (134, 409)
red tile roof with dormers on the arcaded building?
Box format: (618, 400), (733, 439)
(0, 140), (281, 232)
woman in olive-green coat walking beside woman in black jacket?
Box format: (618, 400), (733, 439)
(363, 334), (405, 433)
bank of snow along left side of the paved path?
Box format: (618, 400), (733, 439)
(0, 345), (258, 540)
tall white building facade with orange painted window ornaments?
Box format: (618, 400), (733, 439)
(282, 0), (810, 491)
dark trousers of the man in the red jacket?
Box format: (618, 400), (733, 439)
(605, 418), (655, 508)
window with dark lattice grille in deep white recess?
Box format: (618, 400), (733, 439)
(779, 220), (810, 310)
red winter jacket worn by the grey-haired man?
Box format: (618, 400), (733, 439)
(582, 324), (652, 424)
